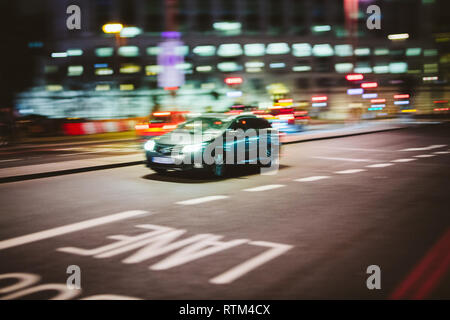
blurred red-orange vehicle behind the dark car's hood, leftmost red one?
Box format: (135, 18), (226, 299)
(135, 111), (189, 139)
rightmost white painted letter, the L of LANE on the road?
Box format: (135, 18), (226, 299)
(209, 241), (293, 284)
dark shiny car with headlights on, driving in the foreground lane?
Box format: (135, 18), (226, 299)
(144, 114), (280, 177)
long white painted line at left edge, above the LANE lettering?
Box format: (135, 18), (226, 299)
(0, 210), (150, 250)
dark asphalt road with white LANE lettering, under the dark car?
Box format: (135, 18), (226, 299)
(0, 124), (450, 299)
